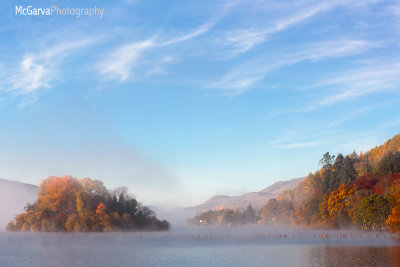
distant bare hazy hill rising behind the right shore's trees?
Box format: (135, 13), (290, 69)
(187, 177), (305, 212)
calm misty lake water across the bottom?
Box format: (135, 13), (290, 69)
(0, 227), (400, 267)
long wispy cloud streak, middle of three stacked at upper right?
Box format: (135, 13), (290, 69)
(209, 40), (374, 95)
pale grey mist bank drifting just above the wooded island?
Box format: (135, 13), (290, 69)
(0, 141), (178, 205)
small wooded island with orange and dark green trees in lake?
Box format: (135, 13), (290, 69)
(7, 176), (170, 232)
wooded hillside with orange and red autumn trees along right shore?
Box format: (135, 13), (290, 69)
(187, 134), (400, 237)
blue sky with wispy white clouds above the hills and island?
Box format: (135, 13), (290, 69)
(0, 0), (400, 207)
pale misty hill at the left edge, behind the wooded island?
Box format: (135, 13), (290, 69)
(0, 179), (38, 231)
